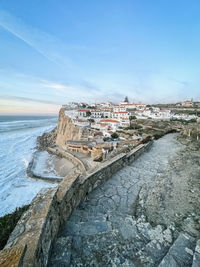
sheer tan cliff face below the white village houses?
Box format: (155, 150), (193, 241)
(56, 108), (93, 147)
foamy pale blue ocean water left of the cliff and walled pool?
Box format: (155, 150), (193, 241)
(0, 116), (57, 217)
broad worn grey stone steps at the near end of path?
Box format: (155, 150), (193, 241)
(49, 214), (200, 267)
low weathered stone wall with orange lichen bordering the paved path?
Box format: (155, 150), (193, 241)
(0, 141), (152, 267)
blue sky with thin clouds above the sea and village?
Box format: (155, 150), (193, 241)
(0, 0), (200, 114)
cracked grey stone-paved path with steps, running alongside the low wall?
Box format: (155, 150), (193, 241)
(49, 134), (200, 267)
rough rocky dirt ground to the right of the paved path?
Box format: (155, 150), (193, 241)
(137, 139), (200, 239)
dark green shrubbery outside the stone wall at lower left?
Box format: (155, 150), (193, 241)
(0, 205), (29, 249)
